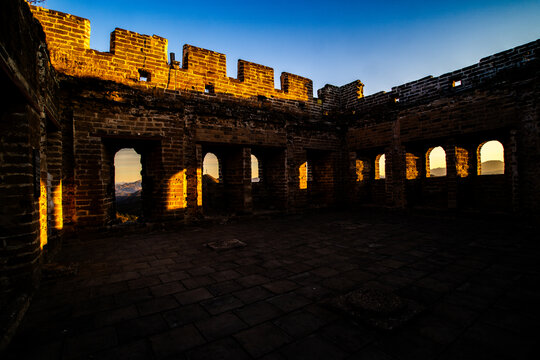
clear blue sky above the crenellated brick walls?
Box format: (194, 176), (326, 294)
(35, 0), (540, 94)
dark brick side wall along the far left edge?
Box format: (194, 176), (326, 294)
(0, 1), (61, 352)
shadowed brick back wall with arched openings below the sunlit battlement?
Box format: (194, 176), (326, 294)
(61, 77), (342, 228)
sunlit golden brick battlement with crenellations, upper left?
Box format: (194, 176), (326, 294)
(30, 6), (313, 101)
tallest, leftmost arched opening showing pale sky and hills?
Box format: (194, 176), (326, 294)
(114, 148), (142, 222)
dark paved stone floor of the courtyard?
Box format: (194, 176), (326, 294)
(6, 210), (540, 359)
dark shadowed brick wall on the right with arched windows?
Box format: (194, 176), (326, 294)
(348, 41), (540, 212)
